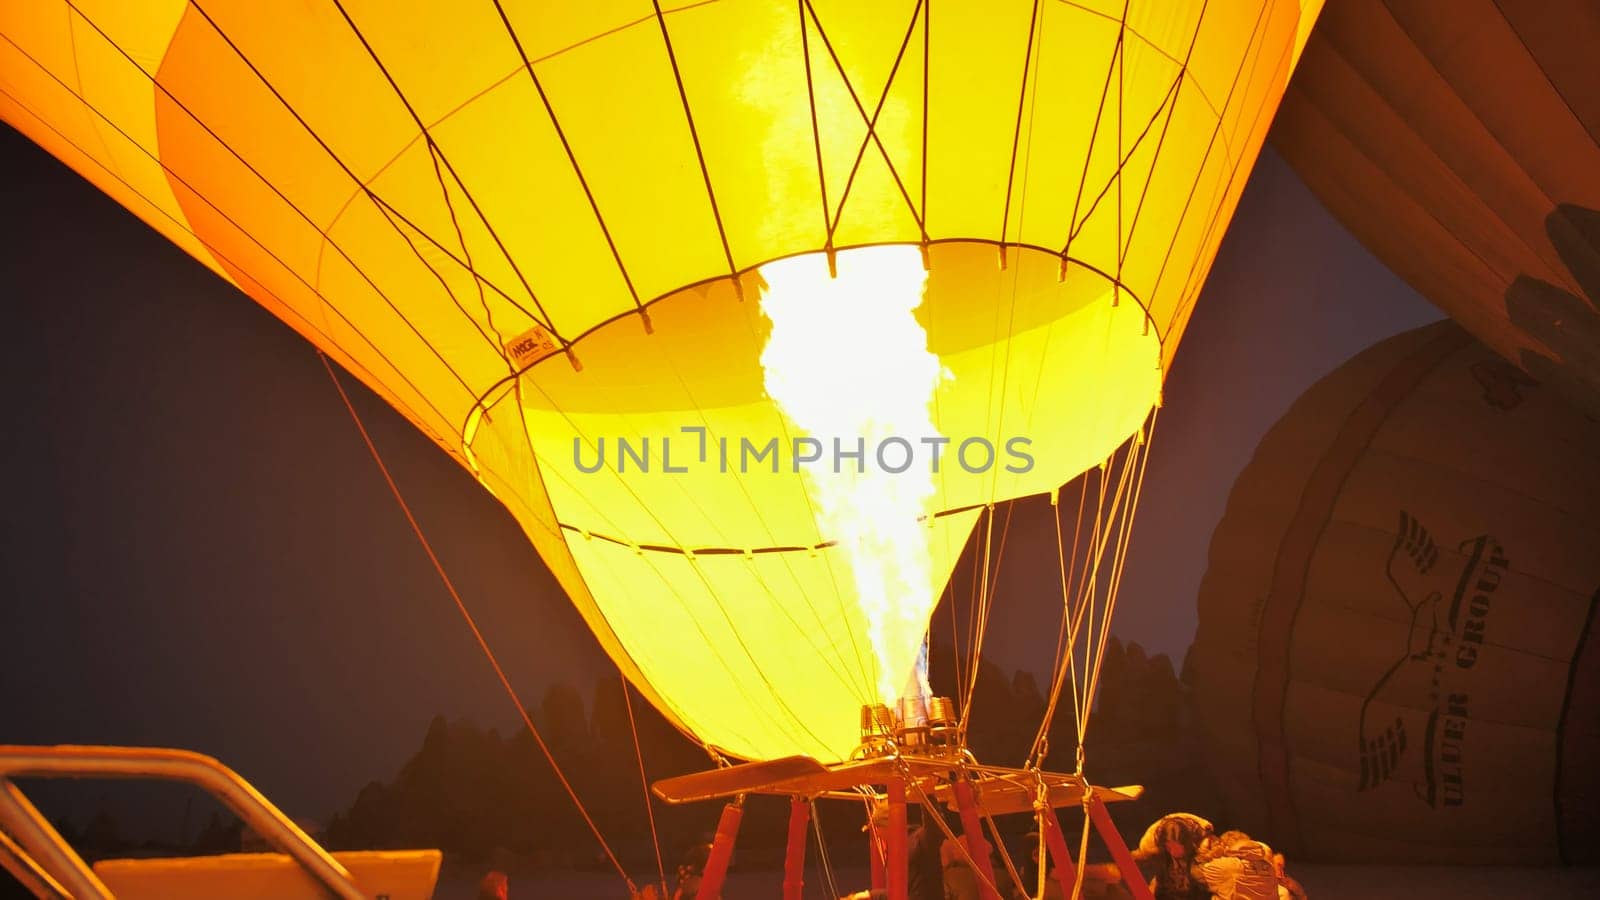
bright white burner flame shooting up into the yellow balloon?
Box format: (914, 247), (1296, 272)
(762, 247), (942, 703)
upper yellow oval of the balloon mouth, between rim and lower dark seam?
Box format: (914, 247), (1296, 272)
(464, 240), (1163, 544)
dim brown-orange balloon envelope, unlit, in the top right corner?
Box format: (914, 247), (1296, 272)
(1272, 0), (1600, 415)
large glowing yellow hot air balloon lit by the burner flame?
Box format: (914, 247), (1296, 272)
(0, 0), (1320, 761)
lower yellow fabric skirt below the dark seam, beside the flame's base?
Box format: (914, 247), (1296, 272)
(568, 511), (978, 761)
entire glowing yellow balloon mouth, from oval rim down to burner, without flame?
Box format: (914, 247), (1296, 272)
(469, 240), (1162, 761)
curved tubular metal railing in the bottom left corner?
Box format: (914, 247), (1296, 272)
(0, 745), (366, 900)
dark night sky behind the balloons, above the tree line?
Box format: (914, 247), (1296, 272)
(0, 120), (1440, 818)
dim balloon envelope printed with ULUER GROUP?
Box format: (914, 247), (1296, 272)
(1189, 322), (1600, 865)
